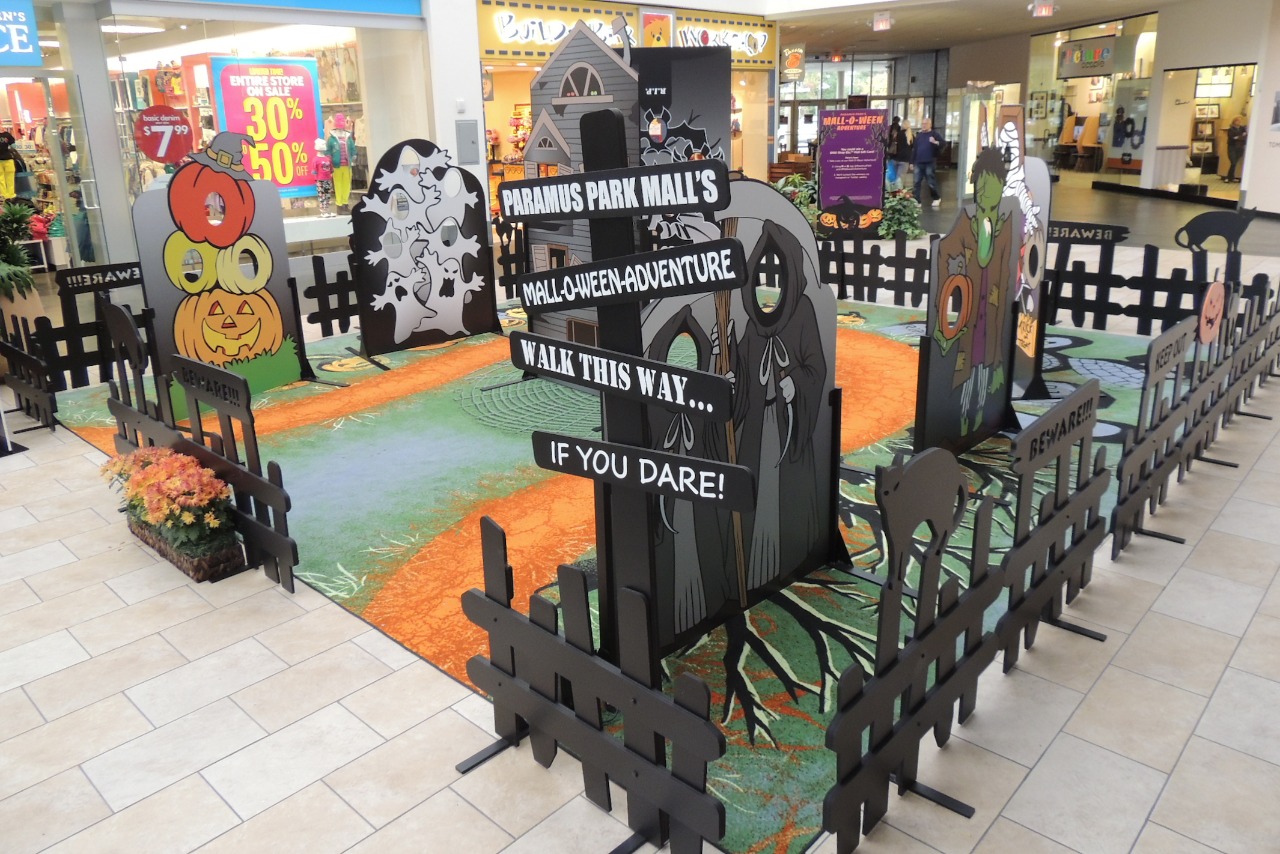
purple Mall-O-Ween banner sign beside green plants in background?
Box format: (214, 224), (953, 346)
(818, 110), (888, 212)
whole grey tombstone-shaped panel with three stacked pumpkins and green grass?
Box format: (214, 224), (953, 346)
(133, 132), (303, 402)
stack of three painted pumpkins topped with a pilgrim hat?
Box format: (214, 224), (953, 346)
(164, 132), (284, 367)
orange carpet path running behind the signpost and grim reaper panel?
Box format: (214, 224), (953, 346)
(361, 329), (916, 682)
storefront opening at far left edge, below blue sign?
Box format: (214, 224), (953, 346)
(0, 68), (106, 269)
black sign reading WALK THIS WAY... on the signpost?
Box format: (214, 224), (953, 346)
(511, 332), (733, 421)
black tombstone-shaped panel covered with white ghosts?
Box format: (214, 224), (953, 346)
(351, 140), (499, 356)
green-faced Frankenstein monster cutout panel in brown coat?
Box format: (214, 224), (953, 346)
(915, 147), (1023, 453)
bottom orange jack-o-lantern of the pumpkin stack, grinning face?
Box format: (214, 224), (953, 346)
(173, 288), (284, 367)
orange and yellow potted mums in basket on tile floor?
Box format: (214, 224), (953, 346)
(102, 448), (244, 581)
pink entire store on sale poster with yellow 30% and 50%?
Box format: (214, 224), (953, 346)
(210, 56), (324, 198)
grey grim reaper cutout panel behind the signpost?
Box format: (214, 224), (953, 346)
(643, 179), (837, 649)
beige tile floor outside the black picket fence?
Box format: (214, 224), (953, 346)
(0, 383), (1280, 854)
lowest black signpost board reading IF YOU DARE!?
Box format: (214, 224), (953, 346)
(534, 430), (755, 512)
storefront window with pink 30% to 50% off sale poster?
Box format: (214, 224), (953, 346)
(101, 17), (429, 251)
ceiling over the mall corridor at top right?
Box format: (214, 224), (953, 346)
(771, 0), (1169, 58)
